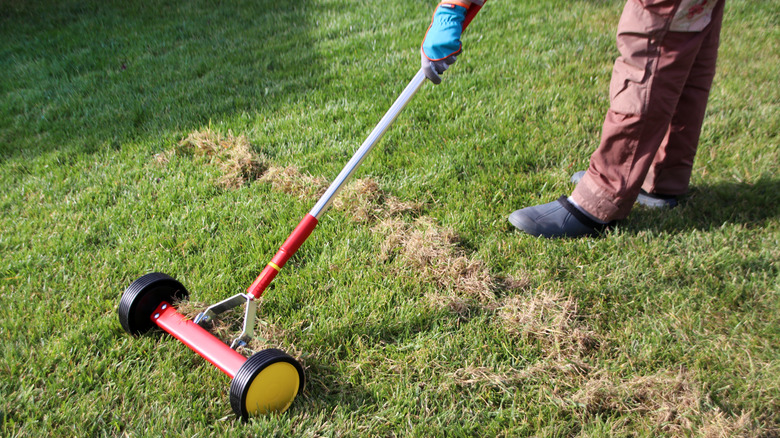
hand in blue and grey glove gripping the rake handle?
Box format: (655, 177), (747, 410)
(420, 2), (468, 84)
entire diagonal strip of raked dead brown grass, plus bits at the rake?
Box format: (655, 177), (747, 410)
(152, 153), (760, 438)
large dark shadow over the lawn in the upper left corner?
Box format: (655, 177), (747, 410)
(0, 0), (322, 160)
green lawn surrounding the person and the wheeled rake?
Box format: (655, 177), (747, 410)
(0, 0), (780, 436)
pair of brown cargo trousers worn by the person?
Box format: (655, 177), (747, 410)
(572, 0), (725, 221)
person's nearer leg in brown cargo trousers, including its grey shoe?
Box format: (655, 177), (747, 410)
(509, 0), (725, 237)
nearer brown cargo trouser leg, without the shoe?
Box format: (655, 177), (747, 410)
(571, 2), (724, 222)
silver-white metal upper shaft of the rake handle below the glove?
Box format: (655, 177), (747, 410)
(309, 69), (425, 220)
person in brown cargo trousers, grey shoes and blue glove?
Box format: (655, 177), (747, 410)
(420, 0), (725, 238)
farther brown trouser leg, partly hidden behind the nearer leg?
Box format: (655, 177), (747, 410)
(642, 1), (725, 195)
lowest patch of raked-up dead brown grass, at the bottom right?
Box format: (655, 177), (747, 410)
(447, 359), (760, 438)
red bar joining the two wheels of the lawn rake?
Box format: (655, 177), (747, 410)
(152, 302), (246, 379)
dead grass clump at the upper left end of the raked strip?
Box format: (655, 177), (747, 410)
(169, 128), (266, 188)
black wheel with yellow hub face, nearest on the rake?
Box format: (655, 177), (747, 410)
(230, 348), (305, 421)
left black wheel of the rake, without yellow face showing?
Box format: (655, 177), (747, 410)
(118, 272), (190, 335)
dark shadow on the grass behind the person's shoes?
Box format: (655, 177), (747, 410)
(627, 178), (780, 233)
